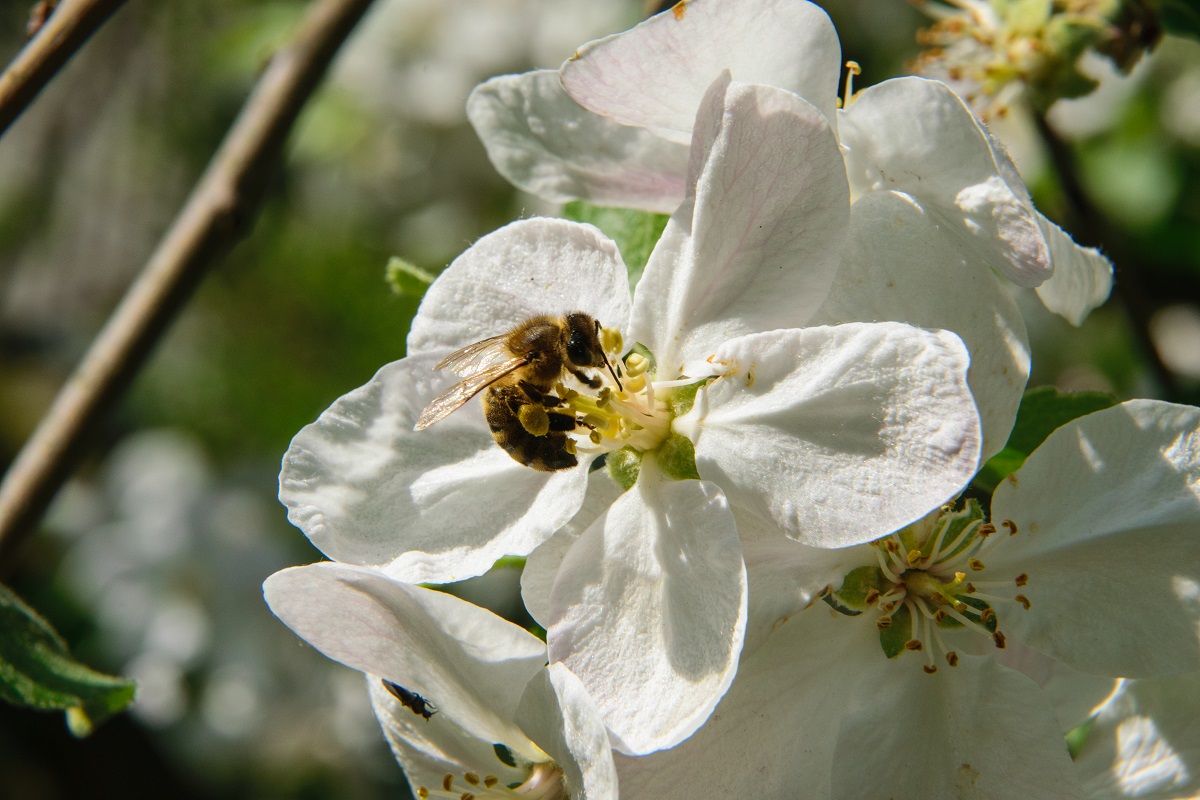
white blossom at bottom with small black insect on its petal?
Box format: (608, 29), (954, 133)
(263, 563), (618, 800)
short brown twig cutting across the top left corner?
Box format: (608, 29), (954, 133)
(0, 0), (125, 136)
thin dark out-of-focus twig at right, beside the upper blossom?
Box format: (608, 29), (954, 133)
(1033, 112), (1180, 401)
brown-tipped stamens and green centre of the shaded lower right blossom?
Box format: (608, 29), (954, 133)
(823, 500), (1030, 674)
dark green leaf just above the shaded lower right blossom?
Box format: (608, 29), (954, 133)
(973, 386), (1117, 493)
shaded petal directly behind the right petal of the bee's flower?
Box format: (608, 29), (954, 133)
(814, 192), (1045, 461)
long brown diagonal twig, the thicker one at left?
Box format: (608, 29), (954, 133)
(0, 0), (371, 563)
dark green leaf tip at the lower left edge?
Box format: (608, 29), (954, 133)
(0, 585), (134, 736)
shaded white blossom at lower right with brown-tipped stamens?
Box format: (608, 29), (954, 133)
(618, 401), (1200, 800)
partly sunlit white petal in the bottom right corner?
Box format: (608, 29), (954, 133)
(1075, 673), (1200, 800)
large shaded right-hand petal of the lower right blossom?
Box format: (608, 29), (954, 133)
(988, 401), (1200, 676)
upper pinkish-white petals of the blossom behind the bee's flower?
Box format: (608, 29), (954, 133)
(468, 0), (1111, 321)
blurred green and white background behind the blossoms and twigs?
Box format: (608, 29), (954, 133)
(0, 0), (1200, 800)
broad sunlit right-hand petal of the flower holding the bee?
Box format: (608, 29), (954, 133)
(674, 323), (979, 547)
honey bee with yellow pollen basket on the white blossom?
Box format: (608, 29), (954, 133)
(414, 312), (620, 473)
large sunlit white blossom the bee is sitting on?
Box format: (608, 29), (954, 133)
(280, 80), (984, 752)
